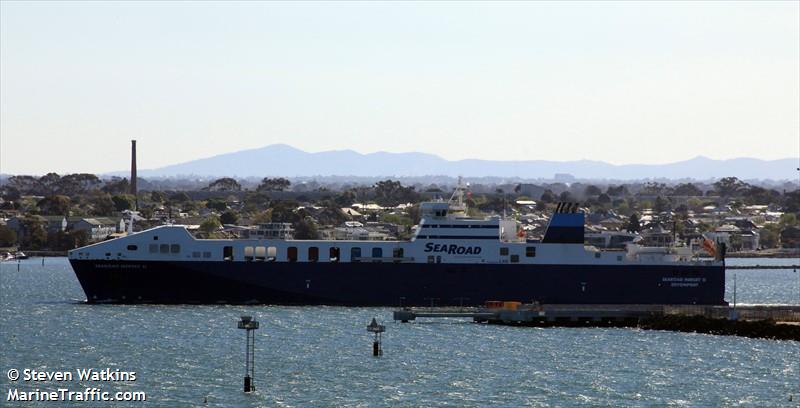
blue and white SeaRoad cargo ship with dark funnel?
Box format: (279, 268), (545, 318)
(69, 185), (726, 306)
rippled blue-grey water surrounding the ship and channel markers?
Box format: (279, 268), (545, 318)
(0, 259), (800, 407)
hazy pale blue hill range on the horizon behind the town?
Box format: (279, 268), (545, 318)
(119, 144), (798, 180)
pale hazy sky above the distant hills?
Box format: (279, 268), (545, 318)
(0, 1), (800, 174)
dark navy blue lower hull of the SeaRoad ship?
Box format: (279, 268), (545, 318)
(70, 260), (725, 306)
